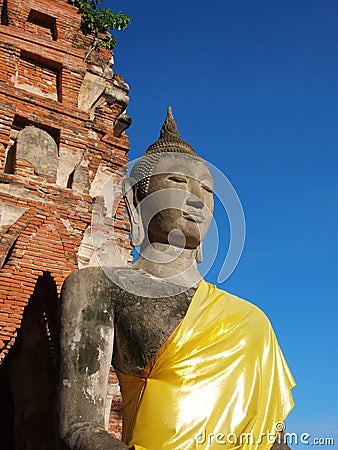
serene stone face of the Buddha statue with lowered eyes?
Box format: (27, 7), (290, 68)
(139, 153), (214, 249)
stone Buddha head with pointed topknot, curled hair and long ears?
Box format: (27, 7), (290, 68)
(123, 107), (213, 268)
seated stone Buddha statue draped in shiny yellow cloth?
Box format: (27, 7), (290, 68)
(58, 108), (294, 450)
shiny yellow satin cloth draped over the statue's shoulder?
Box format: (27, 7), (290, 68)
(117, 280), (295, 450)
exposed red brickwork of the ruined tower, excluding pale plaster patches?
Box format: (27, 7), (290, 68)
(0, 0), (131, 442)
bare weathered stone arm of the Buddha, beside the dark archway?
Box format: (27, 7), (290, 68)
(58, 268), (128, 450)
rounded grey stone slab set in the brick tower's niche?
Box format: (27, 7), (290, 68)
(16, 126), (58, 177)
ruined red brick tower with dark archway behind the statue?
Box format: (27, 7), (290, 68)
(0, 0), (130, 450)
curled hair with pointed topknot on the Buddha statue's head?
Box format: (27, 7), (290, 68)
(130, 106), (199, 201)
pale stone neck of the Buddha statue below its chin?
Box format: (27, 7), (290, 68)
(133, 242), (202, 288)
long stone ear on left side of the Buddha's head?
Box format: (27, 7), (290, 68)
(122, 178), (144, 247)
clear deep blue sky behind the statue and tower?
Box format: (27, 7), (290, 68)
(104, 0), (338, 448)
